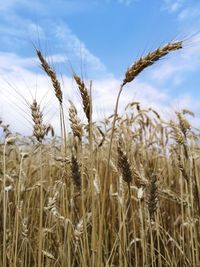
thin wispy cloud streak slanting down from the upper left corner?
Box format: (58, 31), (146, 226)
(0, 0), (106, 74)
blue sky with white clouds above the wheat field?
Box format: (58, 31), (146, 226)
(0, 0), (200, 134)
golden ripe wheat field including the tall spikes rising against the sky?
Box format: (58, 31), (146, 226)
(0, 42), (200, 267)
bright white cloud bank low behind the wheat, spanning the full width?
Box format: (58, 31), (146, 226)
(0, 53), (200, 134)
